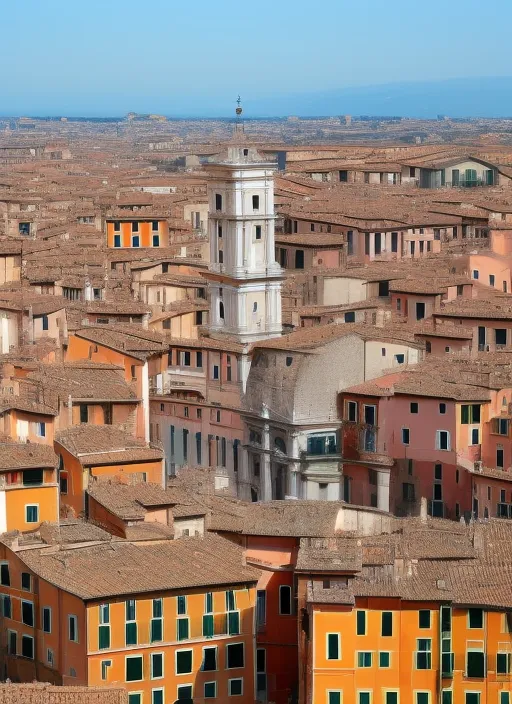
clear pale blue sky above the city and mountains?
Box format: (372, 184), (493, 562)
(0, 0), (512, 115)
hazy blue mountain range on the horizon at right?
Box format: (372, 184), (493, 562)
(244, 76), (512, 118)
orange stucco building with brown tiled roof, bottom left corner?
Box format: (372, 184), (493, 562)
(0, 521), (258, 704)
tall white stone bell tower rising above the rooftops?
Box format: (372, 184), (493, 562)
(206, 129), (283, 343)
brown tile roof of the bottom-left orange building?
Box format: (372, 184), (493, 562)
(17, 535), (260, 600)
